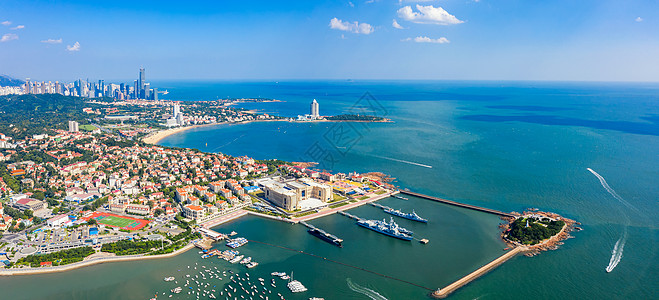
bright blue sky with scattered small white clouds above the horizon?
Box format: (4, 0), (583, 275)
(0, 0), (659, 81)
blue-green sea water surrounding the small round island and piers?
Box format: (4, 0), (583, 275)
(0, 81), (659, 299)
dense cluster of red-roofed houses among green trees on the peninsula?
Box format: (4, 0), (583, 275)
(0, 130), (276, 232)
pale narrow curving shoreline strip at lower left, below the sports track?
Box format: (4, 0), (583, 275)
(0, 243), (195, 276)
